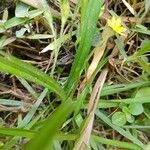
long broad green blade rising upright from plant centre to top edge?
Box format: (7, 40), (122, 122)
(65, 0), (102, 93)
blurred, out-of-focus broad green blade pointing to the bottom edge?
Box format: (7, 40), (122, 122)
(26, 100), (75, 150)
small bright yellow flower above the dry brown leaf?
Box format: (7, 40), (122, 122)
(107, 16), (126, 35)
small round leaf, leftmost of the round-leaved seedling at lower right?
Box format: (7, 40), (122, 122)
(111, 111), (127, 126)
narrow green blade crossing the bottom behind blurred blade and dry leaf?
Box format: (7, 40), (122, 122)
(0, 128), (141, 150)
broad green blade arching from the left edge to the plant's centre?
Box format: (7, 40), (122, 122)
(0, 55), (66, 100)
